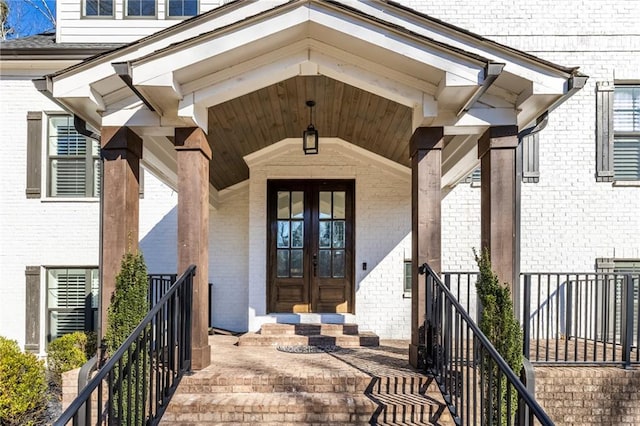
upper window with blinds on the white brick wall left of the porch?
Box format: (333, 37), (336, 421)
(47, 115), (100, 197)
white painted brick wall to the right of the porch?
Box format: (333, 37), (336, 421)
(403, 0), (640, 271)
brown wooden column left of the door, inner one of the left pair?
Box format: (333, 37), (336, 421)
(175, 127), (211, 370)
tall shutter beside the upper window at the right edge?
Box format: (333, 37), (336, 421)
(596, 81), (614, 182)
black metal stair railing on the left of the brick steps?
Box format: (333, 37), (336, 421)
(54, 265), (196, 426)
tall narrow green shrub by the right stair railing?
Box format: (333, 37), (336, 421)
(473, 250), (522, 425)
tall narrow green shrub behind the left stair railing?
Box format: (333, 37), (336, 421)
(105, 253), (149, 424)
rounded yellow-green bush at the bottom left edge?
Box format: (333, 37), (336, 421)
(0, 336), (47, 426)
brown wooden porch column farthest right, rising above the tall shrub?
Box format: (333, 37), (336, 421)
(478, 126), (519, 295)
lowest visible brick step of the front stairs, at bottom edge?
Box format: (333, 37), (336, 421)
(160, 392), (377, 425)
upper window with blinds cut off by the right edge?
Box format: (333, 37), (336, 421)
(613, 85), (640, 181)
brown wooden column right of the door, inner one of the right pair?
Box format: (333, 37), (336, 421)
(409, 127), (444, 367)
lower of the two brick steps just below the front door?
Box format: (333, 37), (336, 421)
(238, 331), (380, 348)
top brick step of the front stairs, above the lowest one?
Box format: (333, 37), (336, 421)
(180, 371), (371, 394)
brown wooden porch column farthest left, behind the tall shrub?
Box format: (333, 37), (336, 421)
(100, 126), (142, 337)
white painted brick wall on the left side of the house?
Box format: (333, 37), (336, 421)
(0, 72), (177, 348)
